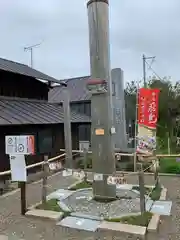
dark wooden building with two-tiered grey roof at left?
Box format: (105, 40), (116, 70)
(0, 58), (90, 179)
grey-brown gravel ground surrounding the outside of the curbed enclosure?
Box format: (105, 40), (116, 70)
(0, 174), (180, 240)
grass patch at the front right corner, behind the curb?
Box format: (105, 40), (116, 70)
(106, 212), (153, 227)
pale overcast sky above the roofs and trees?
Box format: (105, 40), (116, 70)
(0, 0), (180, 84)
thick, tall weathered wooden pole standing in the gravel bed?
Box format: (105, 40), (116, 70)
(87, 0), (116, 199)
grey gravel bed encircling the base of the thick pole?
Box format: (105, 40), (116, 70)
(63, 189), (140, 218)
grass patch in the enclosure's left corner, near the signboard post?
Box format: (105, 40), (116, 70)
(36, 199), (70, 217)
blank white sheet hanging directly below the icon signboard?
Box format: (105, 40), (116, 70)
(9, 155), (27, 182)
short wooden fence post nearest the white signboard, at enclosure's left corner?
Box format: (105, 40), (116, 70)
(42, 155), (49, 205)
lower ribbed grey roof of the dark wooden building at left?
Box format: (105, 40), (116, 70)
(0, 98), (90, 125)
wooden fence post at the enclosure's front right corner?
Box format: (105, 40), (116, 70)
(138, 163), (146, 215)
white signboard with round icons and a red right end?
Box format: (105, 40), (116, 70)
(5, 135), (35, 155)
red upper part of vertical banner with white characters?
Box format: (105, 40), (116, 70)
(137, 88), (159, 129)
